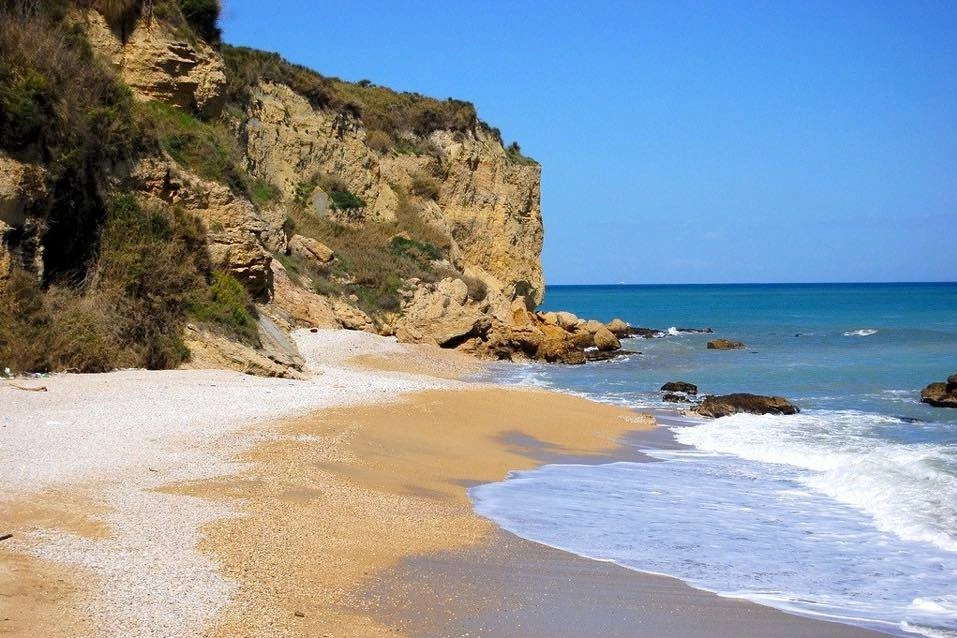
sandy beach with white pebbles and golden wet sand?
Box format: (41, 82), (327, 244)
(0, 331), (888, 636)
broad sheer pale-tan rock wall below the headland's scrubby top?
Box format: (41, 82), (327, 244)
(239, 82), (544, 312)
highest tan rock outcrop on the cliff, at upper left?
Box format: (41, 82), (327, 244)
(83, 9), (226, 116)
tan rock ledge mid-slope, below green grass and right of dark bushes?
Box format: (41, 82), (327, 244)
(132, 160), (277, 298)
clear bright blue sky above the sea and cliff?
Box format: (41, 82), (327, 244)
(221, 0), (957, 284)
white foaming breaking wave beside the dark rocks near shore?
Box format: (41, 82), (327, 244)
(675, 410), (957, 552)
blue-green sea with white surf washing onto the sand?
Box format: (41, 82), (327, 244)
(470, 283), (957, 637)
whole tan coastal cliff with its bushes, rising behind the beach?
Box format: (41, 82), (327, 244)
(0, 0), (608, 375)
